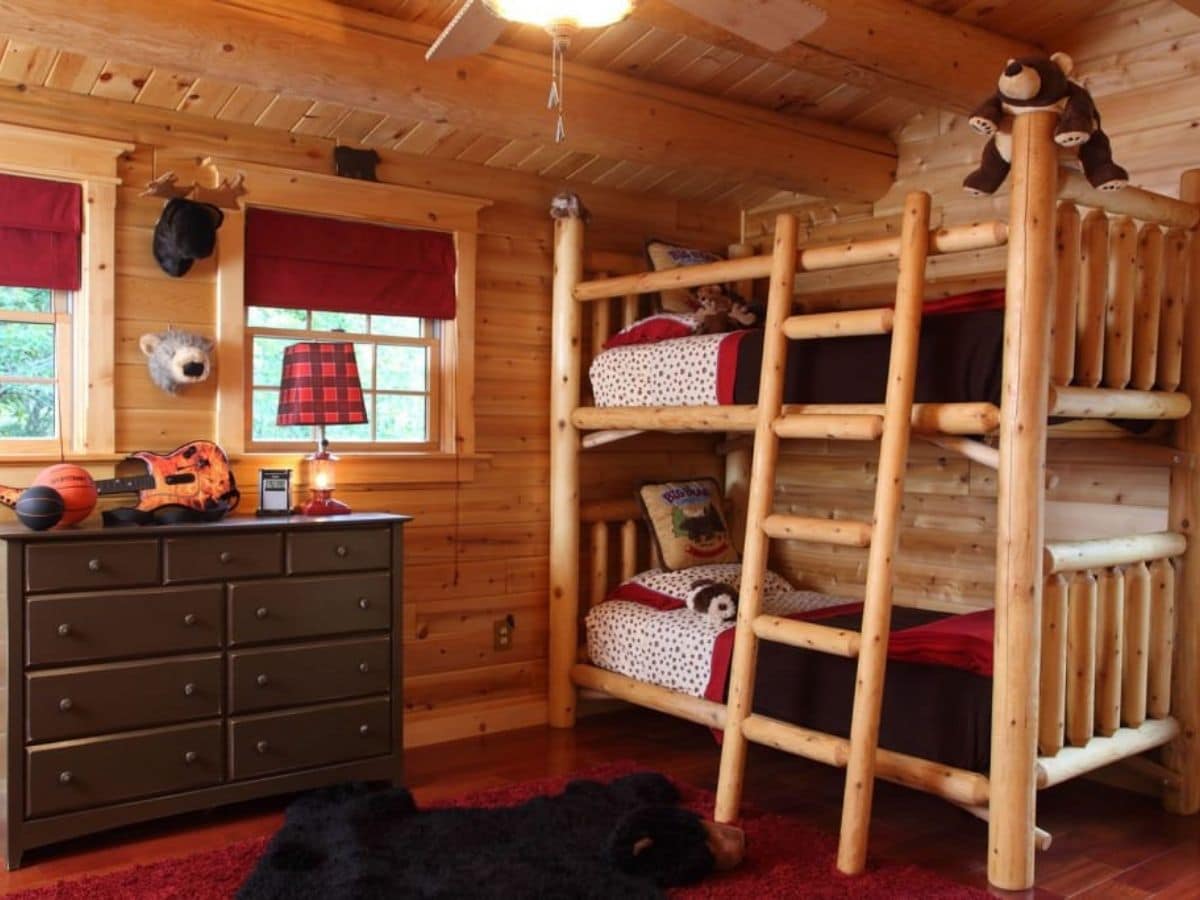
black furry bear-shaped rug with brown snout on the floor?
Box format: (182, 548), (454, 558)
(238, 773), (744, 900)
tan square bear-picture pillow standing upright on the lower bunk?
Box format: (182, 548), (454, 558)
(637, 478), (738, 571)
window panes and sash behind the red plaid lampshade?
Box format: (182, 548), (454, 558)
(246, 306), (442, 450)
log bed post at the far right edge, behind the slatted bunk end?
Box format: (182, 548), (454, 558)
(1163, 169), (1200, 815)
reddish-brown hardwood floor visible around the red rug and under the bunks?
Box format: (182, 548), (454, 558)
(0, 710), (1200, 899)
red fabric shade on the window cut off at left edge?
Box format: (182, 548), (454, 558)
(0, 175), (83, 290)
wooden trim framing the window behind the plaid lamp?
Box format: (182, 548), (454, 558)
(172, 154), (491, 473)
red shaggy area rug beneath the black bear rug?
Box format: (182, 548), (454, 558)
(10, 764), (989, 900)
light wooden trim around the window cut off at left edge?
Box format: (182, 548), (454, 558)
(0, 122), (134, 460)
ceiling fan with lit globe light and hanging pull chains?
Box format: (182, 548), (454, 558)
(425, 0), (826, 143)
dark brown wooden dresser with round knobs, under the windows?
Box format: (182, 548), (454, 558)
(0, 514), (408, 869)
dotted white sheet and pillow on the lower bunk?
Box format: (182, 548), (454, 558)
(587, 563), (847, 697)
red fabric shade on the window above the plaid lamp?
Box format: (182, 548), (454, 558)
(246, 209), (457, 319)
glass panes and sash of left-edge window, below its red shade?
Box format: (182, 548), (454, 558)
(0, 286), (71, 444)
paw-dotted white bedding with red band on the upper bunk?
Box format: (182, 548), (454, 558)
(588, 331), (743, 407)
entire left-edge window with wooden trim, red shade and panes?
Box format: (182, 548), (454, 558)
(0, 122), (133, 460)
